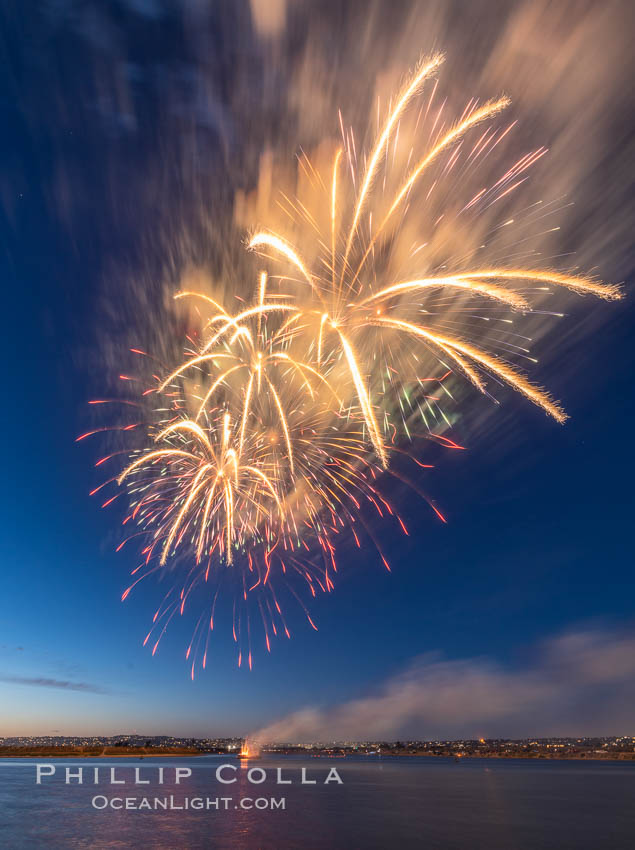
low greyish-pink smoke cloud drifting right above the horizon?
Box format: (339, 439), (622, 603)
(251, 629), (635, 742)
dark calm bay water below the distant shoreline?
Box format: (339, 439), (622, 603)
(0, 756), (635, 850)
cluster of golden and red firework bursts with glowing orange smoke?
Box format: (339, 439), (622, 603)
(84, 55), (621, 676)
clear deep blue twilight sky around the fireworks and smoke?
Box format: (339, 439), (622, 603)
(0, 3), (635, 735)
